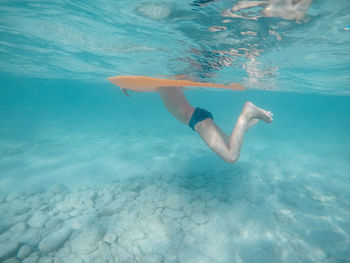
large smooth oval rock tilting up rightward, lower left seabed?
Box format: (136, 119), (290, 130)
(39, 227), (72, 253)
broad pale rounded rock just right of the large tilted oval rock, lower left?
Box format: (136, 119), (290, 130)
(71, 229), (99, 255)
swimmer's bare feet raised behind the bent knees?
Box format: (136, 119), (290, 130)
(241, 101), (273, 125)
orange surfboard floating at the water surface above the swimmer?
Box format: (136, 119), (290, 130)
(108, 76), (244, 92)
